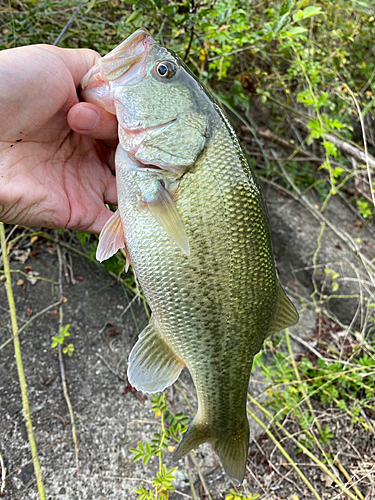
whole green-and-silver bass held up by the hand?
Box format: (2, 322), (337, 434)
(80, 29), (298, 485)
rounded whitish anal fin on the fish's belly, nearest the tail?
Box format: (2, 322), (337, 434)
(128, 318), (185, 393)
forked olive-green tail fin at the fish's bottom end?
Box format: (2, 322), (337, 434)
(173, 415), (250, 486)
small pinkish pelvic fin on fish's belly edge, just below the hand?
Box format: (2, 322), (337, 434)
(96, 210), (130, 271)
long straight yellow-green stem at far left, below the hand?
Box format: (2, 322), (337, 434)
(0, 222), (46, 500)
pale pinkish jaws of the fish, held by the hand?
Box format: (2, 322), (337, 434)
(78, 29), (156, 114)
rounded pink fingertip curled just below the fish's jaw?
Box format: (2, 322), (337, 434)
(68, 102), (118, 144)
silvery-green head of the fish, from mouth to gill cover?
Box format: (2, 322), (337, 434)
(80, 29), (212, 174)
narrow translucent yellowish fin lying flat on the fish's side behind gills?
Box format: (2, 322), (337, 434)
(143, 182), (190, 256)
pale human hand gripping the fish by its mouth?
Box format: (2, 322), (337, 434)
(0, 45), (118, 234)
